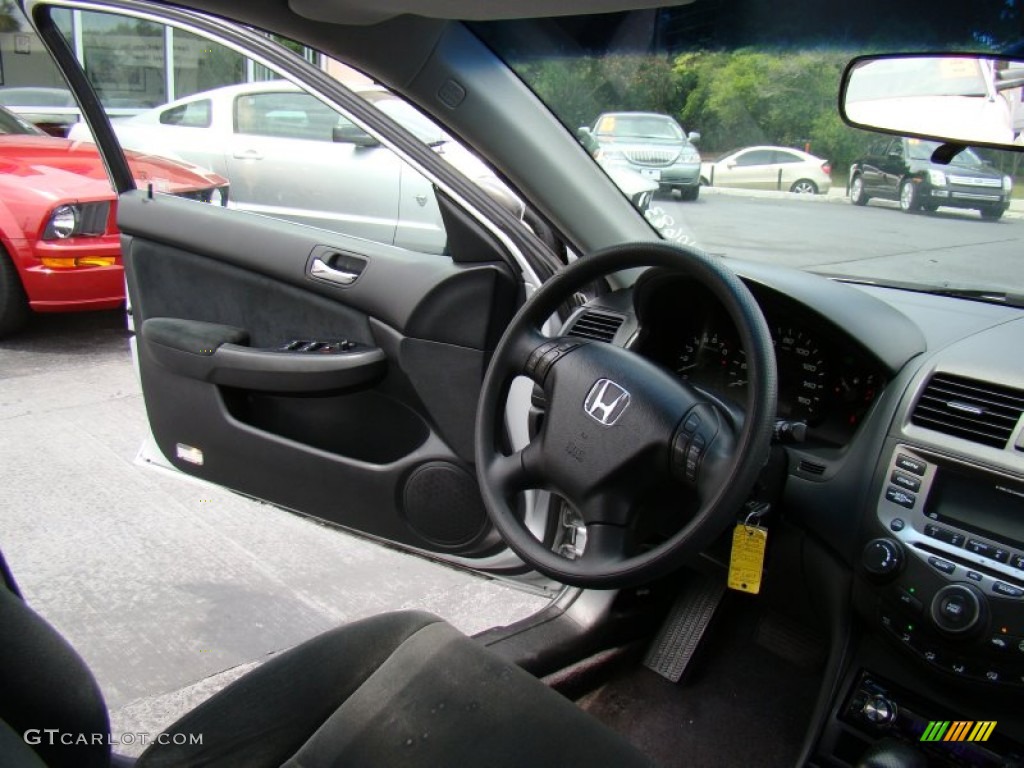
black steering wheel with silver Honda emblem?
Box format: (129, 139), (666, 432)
(476, 243), (777, 588)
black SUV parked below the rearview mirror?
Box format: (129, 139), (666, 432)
(849, 138), (1013, 221)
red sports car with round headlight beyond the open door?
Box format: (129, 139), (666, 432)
(0, 108), (227, 337)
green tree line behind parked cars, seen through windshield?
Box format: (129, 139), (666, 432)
(518, 49), (901, 178)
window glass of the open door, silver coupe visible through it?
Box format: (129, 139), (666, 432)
(40, 10), (454, 254)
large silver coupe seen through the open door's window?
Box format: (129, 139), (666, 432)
(69, 80), (657, 253)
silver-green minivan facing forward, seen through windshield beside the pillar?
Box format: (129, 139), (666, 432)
(580, 112), (700, 200)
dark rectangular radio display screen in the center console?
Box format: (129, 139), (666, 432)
(925, 467), (1024, 548)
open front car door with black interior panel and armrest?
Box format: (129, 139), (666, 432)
(29, 4), (542, 572)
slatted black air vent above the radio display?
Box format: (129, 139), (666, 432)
(910, 374), (1024, 447)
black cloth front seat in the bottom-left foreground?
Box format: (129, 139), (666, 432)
(0, 558), (650, 768)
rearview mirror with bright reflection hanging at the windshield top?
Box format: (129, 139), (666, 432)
(840, 53), (1024, 147)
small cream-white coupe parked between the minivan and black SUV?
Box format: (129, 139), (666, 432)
(700, 146), (831, 195)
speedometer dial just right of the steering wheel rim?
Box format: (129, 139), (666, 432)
(773, 326), (827, 424)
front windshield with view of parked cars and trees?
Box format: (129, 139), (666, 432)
(473, 0), (1024, 294)
